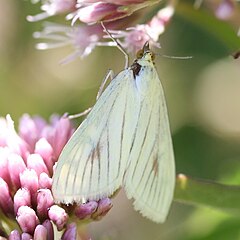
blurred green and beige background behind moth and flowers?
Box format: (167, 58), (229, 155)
(0, 0), (240, 240)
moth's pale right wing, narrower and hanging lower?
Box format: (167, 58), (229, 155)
(123, 75), (175, 222)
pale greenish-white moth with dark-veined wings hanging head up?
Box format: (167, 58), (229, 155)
(52, 43), (175, 222)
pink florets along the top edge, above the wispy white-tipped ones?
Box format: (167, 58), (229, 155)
(27, 0), (160, 23)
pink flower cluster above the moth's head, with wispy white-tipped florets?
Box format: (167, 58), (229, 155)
(28, 0), (174, 63)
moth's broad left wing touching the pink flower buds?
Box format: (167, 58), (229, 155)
(52, 69), (137, 203)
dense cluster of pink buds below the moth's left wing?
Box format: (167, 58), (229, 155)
(0, 115), (112, 240)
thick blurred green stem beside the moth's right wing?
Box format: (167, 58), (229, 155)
(174, 174), (240, 214)
